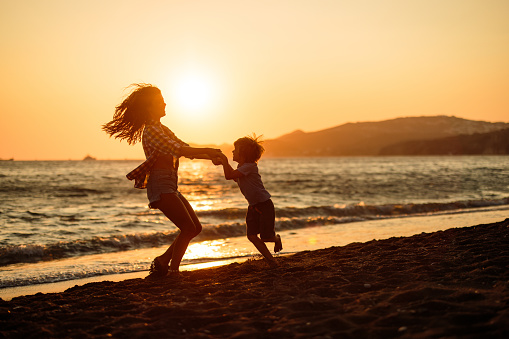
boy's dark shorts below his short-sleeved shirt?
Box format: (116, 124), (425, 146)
(246, 199), (276, 240)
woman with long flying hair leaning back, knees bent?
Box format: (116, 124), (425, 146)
(103, 84), (221, 278)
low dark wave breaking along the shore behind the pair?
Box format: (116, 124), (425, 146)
(0, 198), (509, 266)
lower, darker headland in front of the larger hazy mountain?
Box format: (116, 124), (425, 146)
(380, 128), (509, 155)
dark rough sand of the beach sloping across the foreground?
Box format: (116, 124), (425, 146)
(0, 219), (509, 338)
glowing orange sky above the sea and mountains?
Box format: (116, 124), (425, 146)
(0, 0), (509, 160)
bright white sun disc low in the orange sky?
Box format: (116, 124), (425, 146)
(171, 72), (217, 117)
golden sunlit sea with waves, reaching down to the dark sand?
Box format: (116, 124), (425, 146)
(0, 156), (509, 300)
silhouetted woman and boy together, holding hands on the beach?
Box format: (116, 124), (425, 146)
(102, 84), (283, 279)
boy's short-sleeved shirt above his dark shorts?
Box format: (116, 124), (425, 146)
(237, 162), (270, 205)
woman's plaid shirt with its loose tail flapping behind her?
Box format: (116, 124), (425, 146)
(126, 122), (189, 188)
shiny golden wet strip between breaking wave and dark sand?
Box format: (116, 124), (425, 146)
(0, 209), (507, 300)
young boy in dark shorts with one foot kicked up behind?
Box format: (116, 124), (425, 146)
(217, 137), (283, 267)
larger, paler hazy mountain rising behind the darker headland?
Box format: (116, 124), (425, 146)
(258, 116), (509, 157)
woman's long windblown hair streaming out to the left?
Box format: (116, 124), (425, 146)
(102, 84), (161, 145)
